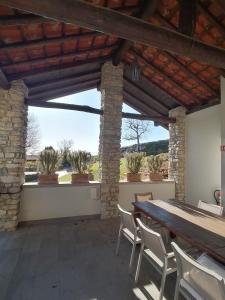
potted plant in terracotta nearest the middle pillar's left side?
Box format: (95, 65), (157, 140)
(69, 151), (91, 184)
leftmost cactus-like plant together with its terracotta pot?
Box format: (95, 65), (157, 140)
(38, 147), (59, 184)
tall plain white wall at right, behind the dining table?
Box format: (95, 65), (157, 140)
(185, 105), (221, 205)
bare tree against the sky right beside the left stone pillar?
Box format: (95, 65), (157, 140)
(26, 114), (40, 154)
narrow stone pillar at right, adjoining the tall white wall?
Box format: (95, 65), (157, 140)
(169, 106), (186, 201)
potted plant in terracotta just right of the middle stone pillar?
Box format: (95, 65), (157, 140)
(126, 152), (143, 182)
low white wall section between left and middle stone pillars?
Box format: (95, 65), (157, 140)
(20, 184), (100, 221)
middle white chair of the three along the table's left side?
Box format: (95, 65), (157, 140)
(135, 219), (176, 300)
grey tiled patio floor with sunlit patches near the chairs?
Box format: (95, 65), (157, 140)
(0, 219), (179, 300)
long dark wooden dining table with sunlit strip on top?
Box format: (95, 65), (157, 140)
(133, 200), (225, 264)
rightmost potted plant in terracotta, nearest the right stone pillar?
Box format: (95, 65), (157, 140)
(148, 155), (163, 181)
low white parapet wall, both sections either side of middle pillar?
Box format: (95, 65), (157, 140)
(20, 182), (175, 221)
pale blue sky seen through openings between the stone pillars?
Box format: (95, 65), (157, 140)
(29, 89), (168, 155)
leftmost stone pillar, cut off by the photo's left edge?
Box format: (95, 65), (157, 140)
(0, 80), (27, 231)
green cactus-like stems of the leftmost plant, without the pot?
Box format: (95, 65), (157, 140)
(39, 147), (59, 175)
